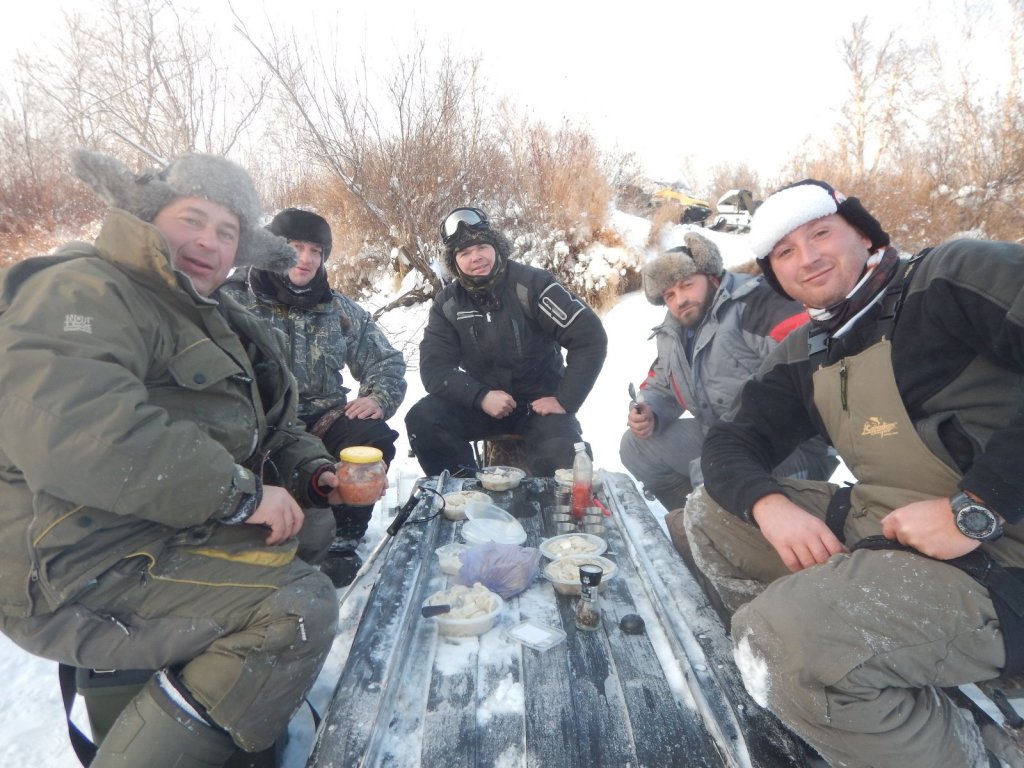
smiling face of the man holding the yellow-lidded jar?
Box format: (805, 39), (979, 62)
(153, 198), (241, 296)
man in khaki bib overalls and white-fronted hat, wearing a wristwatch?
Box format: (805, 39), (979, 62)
(686, 179), (1024, 768)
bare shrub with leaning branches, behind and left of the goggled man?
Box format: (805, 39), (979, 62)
(236, 14), (504, 311)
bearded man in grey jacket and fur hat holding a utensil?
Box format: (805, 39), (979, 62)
(620, 227), (836, 557)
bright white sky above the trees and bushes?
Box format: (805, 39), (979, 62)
(0, 0), (1007, 186)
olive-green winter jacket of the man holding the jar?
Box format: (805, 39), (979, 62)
(0, 210), (330, 615)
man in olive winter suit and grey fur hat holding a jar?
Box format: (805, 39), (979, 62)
(0, 151), (341, 768)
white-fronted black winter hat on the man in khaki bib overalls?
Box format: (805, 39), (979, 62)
(746, 178), (890, 299)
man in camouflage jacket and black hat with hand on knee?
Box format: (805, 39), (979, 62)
(221, 208), (406, 587)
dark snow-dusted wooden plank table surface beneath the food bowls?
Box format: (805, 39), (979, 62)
(308, 475), (802, 768)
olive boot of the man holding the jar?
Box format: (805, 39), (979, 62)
(92, 672), (234, 768)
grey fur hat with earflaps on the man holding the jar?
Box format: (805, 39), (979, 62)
(72, 150), (298, 272)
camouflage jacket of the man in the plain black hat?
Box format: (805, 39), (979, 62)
(220, 273), (407, 420)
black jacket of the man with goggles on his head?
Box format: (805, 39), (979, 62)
(420, 261), (608, 414)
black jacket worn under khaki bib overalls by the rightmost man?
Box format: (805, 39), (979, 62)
(701, 240), (1024, 523)
